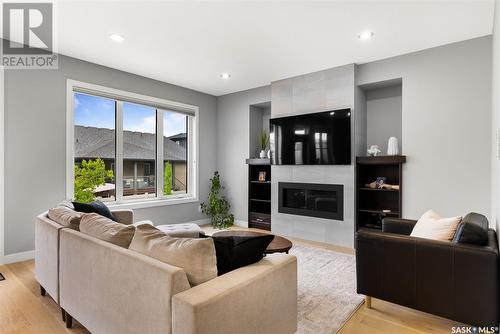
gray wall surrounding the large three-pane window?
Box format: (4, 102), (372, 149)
(5, 56), (217, 255)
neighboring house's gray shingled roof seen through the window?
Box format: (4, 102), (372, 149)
(75, 125), (186, 161)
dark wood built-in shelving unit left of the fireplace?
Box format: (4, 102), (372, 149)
(246, 159), (271, 231)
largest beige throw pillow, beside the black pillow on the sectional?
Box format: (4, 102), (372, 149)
(129, 224), (217, 285)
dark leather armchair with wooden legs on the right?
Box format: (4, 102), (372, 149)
(356, 214), (499, 326)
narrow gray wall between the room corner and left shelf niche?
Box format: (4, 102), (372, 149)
(217, 86), (271, 226)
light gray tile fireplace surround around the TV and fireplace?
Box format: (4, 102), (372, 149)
(271, 64), (366, 248)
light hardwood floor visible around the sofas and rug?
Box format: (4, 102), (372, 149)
(0, 227), (460, 334)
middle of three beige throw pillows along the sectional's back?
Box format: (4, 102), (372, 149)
(80, 213), (135, 248)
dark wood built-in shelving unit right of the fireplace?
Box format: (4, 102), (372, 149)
(356, 155), (406, 230)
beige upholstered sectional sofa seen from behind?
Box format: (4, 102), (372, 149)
(35, 211), (297, 334)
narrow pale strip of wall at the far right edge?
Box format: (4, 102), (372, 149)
(491, 0), (500, 234)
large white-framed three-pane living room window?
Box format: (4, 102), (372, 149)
(67, 80), (198, 207)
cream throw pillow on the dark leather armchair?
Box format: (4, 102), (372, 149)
(410, 210), (462, 241)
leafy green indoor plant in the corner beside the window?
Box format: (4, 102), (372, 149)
(201, 171), (234, 229)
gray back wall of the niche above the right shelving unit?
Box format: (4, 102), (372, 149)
(365, 85), (402, 155)
